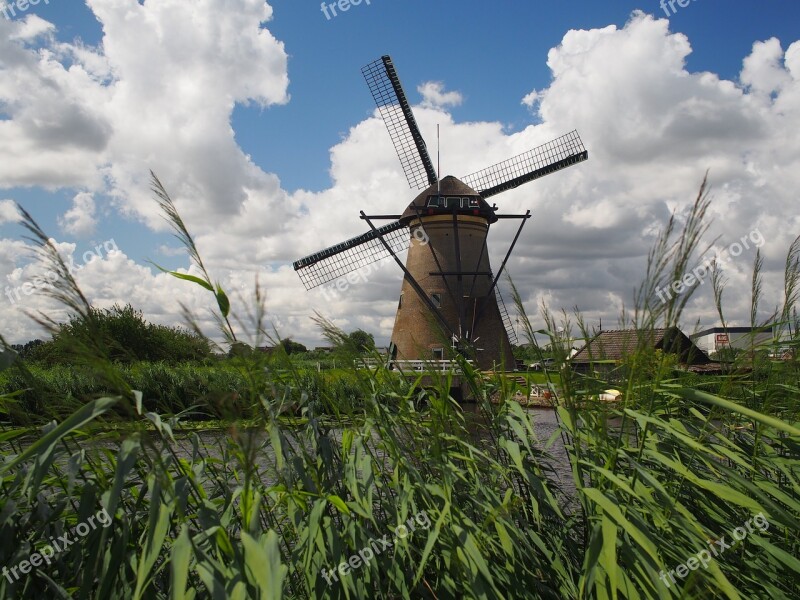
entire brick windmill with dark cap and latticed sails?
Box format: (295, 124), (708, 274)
(293, 56), (589, 369)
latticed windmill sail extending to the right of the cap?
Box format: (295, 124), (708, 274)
(462, 131), (589, 198)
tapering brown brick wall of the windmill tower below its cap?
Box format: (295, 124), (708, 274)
(392, 214), (514, 369)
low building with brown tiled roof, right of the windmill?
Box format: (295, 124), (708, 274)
(569, 327), (721, 375)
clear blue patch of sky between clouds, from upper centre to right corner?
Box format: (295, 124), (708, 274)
(244, 0), (800, 190)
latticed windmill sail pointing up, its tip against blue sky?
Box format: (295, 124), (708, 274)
(361, 56), (437, 190)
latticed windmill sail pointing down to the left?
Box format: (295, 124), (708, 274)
(293, 221), (411, 290)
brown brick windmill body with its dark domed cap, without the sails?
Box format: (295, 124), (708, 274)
(392, 177), (514, 369)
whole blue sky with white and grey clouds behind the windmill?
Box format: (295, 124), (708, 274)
(0, 0), (800, 347)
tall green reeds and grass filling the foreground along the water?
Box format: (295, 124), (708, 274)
(0, 180), (800, 599)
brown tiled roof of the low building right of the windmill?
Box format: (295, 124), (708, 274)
(571, 327), (711, 365)
